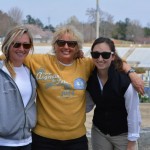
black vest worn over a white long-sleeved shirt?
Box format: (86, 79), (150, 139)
(87, 65), (131, 136)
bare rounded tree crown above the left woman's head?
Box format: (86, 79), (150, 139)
(8, 7), (23, 24)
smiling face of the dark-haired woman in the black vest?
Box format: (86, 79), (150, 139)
(93, 43), (114, 70)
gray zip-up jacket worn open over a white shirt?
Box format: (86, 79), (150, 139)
(0, 62), (37, 140)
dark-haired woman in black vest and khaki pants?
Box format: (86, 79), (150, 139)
(87, 37), (141, 150)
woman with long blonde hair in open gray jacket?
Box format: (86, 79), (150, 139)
(0, 26), (36, 150)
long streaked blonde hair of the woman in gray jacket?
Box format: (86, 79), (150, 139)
(1, 26), (34, 78)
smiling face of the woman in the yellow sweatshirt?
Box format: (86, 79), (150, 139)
(54, 33), (78, 64)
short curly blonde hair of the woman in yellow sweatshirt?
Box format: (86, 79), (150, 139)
(51, 25), (83, 50)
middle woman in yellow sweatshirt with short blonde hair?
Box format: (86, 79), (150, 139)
(22, 26), (144, 150)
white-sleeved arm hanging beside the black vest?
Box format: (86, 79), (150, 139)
(124, 84), (141, 141)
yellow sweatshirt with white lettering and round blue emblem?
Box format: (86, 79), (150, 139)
(25, 54), (94, 140)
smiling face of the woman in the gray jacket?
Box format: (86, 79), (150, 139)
(8, 33), (30, 67)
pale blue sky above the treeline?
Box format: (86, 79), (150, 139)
(0, 0), (150, 26)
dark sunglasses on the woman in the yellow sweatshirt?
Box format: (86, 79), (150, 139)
(56, 40), (77, 48)
